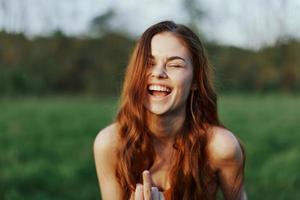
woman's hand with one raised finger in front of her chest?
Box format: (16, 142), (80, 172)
(134, 170), (165, 200)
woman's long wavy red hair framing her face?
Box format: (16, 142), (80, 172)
(116, 21), (243, 200)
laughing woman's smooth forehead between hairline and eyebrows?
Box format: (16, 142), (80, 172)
(151, 32), (189, 60)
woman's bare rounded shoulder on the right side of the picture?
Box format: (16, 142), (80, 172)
(208, 126), (243, 168)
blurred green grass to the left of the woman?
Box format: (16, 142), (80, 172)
(0, 98), (116, 200)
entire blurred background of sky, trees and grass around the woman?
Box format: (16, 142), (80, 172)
(0, 0), (300, 200)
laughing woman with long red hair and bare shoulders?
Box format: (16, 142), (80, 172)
(94, 21), (246, 200)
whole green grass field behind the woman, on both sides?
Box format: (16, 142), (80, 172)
(0, 95), (300, 200)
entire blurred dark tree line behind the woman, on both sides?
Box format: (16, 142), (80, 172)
(0, 31), (300, 96)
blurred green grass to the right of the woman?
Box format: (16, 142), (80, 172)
(219, 95), (300, 200)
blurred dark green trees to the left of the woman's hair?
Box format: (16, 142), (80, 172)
(0, 32), (133, 96)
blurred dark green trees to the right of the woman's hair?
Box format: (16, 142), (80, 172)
(206, 40), (300, 93)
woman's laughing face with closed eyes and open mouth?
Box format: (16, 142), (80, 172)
(145, 32), (193, 115)
